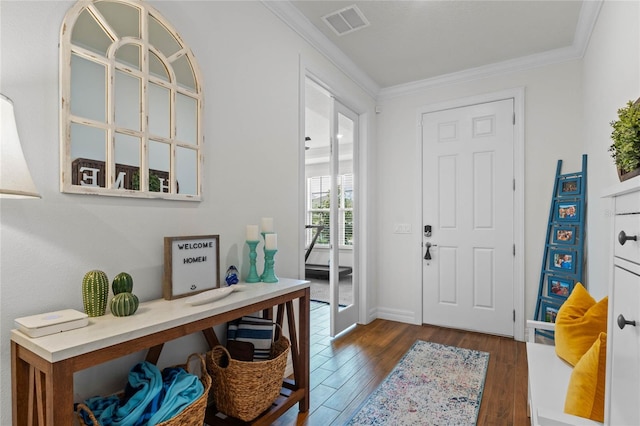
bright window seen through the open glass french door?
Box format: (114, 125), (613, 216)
(307, 174), (353, 248)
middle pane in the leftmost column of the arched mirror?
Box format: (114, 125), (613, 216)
(71, 55), (107, 123)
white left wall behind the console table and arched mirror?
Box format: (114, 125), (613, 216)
(0, 1), (375, 425)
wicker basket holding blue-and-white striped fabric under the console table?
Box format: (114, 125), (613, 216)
(207, 333), (290, 422)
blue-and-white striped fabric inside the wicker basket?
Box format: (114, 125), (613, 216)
(227, 316), (273, 361)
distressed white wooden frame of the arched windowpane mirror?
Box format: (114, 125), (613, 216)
(60, 0), (204, 201)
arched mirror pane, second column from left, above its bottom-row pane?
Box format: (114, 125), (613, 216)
(114, 71), (142, 131)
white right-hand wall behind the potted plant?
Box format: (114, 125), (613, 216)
(582, 1), (640, 298)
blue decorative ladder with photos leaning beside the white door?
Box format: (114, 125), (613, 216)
(534, 154), (587, 338)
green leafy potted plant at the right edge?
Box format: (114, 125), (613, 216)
(609, 99), (640, 181)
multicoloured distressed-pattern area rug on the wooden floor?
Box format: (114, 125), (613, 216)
(348, 340), (489, 426)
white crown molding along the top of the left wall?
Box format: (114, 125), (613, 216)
(261, 0), (380, 99)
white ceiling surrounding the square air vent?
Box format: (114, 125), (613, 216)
(264, 0), (601, 97)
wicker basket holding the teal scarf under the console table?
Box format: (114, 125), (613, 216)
(76, 353), (211, 426)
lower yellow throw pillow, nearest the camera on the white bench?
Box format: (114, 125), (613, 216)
(564, 333), (607, 422)
